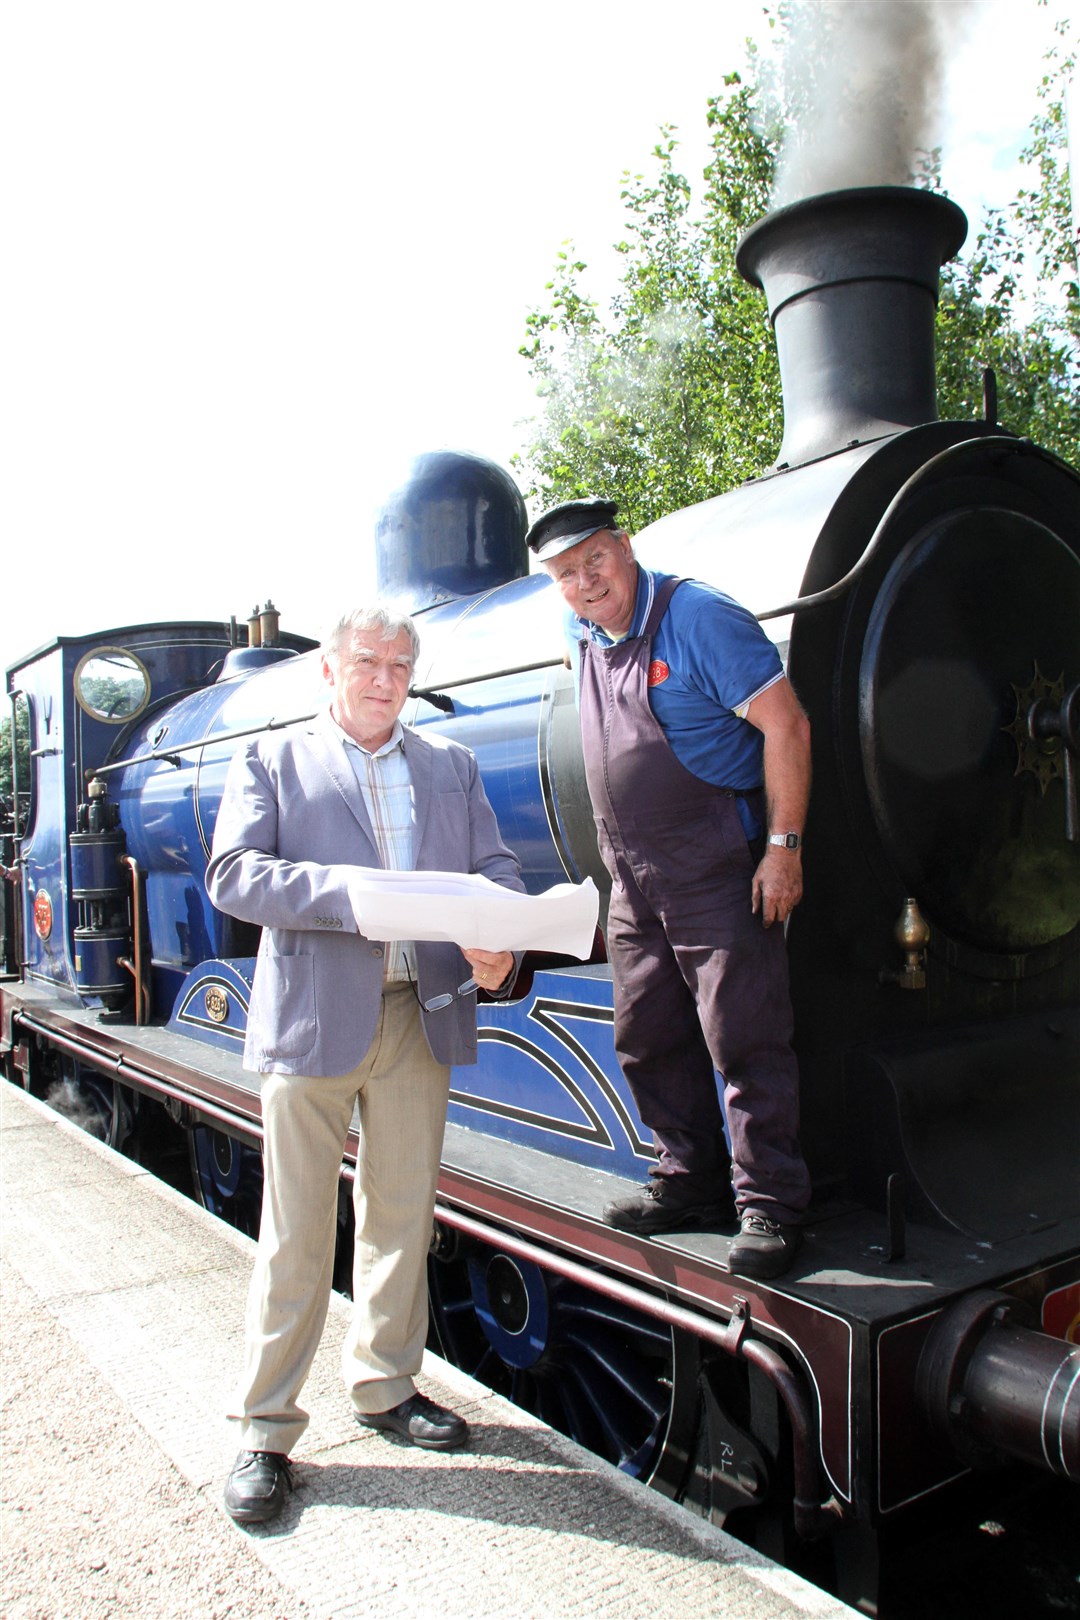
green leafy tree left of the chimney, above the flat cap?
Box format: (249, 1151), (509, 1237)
(517, 63), (782, 528)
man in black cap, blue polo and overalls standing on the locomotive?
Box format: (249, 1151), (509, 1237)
(528, 501), (810, 1278)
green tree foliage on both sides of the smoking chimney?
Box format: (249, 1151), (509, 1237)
(515, 0), (1080, 530)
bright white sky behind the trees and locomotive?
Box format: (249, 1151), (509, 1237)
(0, 0), (1080, 669)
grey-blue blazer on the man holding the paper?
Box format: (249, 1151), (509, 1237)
(206, 710), (525, 1076)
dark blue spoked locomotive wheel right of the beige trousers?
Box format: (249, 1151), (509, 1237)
(427, 1238), (698, 1494)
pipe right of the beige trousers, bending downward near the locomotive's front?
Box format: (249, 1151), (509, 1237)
(427, 1198), (844, 1541)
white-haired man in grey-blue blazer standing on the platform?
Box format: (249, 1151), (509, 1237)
(206, 608), (523, 1523)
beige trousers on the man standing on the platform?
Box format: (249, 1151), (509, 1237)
(230, 983), (450, 1453)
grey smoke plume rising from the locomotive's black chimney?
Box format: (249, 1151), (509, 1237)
(774, 0), (980, 207)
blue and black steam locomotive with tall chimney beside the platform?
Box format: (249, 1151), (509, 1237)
(0, 188), (1080, 1612)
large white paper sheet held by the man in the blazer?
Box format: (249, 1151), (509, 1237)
(348, 867), (599, 961)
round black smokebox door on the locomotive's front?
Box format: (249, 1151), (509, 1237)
(858, 509), (1080, 956)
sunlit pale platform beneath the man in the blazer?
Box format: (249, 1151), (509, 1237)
(0, 1082), (853, 1620)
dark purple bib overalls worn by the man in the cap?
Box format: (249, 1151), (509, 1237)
(580, 580), (810, 1225)
